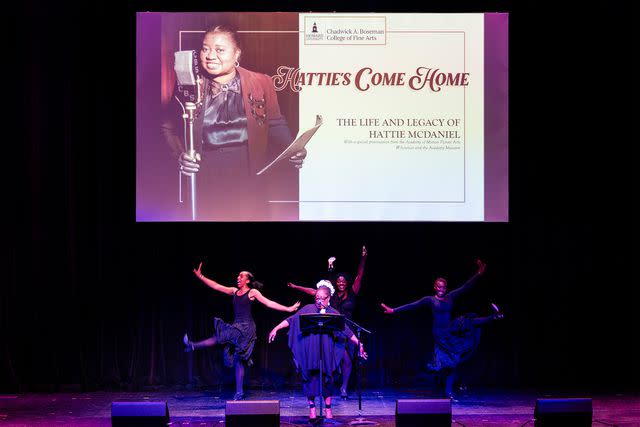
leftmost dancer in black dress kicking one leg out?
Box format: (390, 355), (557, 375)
(183, 263), (300, 400)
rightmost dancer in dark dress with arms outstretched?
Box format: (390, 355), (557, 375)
(380, 260), (503, 398)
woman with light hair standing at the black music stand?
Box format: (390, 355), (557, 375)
(269, 286), (367, 421)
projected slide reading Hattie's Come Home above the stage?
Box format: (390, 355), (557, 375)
(136, 12), (509, 222)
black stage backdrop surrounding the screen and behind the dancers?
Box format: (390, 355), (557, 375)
(5, 1), (640, 392)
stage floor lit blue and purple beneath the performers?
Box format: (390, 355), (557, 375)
(0, 388), (640, 427)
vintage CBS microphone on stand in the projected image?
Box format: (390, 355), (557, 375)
(173, 50), (202, 221)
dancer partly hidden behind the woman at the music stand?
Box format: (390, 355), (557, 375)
(288, 246), (367, 399)
